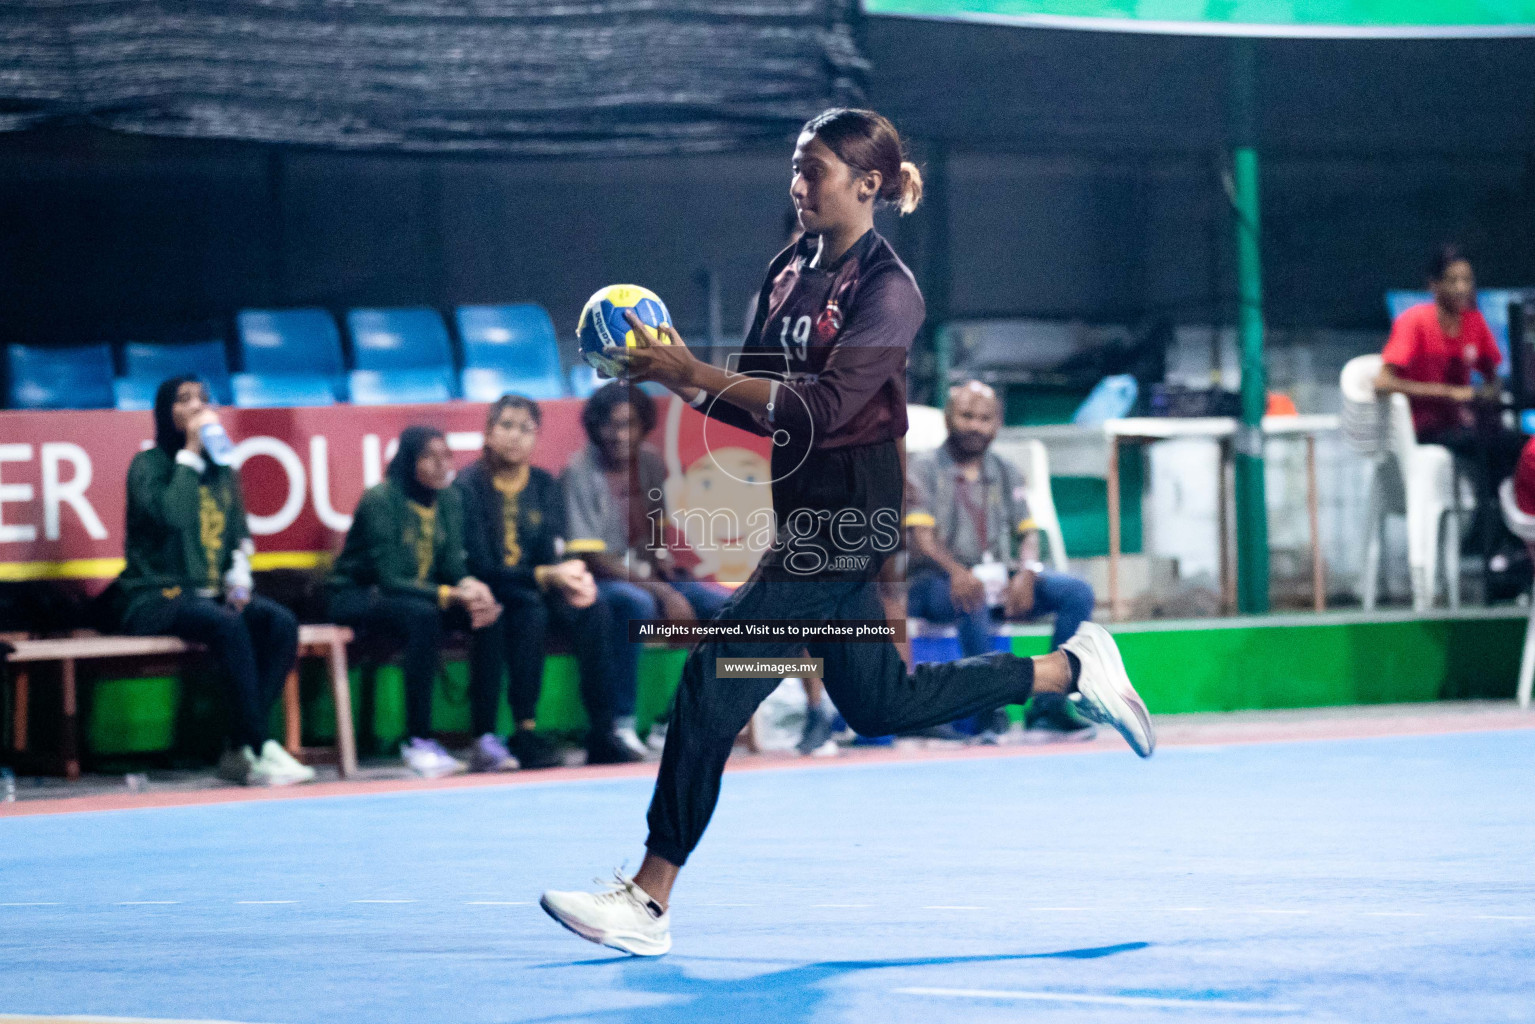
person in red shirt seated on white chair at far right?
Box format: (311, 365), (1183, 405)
(1375, 246), (1523, 574)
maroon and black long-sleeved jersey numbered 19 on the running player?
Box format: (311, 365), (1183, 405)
(708, 230), (926, 448)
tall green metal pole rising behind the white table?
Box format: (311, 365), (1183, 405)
(1231, 38), (1268, 614)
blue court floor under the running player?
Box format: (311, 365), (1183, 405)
(0, 731), (1535, 1024)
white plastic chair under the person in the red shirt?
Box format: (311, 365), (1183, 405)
(1339, 355), (1460, 611)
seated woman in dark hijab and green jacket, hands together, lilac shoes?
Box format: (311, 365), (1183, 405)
(325, 427), (514, 778)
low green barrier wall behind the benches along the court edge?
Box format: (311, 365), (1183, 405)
(59, 613), (1526, 758)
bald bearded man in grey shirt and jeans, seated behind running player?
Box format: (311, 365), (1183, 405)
(906, 381), (1094, 742)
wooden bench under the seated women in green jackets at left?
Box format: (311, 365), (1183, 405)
(6, 625), (358, 778)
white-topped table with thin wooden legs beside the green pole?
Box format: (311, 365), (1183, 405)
(1102, 416), (1339, 620)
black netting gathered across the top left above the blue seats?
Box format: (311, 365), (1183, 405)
(0, 0), (867, 155)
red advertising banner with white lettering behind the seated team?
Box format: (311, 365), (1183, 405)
(0, 396), (771, 580)
